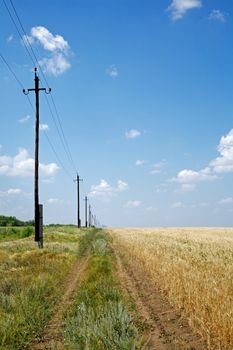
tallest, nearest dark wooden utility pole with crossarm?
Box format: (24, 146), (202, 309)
(23, 68), (51, 248)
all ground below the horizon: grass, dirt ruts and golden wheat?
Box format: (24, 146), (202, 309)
(0, 226), (233, 350)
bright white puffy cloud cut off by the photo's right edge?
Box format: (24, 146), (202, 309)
(210, 129), (233, 173)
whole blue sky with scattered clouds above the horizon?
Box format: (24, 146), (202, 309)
(0, 0), (233, 226)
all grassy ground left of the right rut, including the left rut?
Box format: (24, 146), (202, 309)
(0, 226), (141, 350)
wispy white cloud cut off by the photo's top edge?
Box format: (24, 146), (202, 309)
(167, 0), (202, 21)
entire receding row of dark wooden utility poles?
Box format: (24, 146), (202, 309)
(23, 68), (99, 248)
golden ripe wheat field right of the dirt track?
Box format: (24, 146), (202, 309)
(109, 228), (233, 350)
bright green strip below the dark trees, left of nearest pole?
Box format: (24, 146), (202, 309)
(0, 226), (34, 241)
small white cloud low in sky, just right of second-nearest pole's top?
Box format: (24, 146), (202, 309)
(89, 179), (128, 200)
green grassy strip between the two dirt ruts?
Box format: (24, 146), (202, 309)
(63, 230), (139, 350)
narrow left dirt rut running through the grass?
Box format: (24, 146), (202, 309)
(30, 258), (88, 350)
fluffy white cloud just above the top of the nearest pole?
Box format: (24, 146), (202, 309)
(23, 26), (71, 76)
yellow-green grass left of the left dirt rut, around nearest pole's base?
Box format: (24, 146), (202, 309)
(0, 227), (81, 350)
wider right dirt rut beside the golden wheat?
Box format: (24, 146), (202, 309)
(112, 244), (208, 350)
